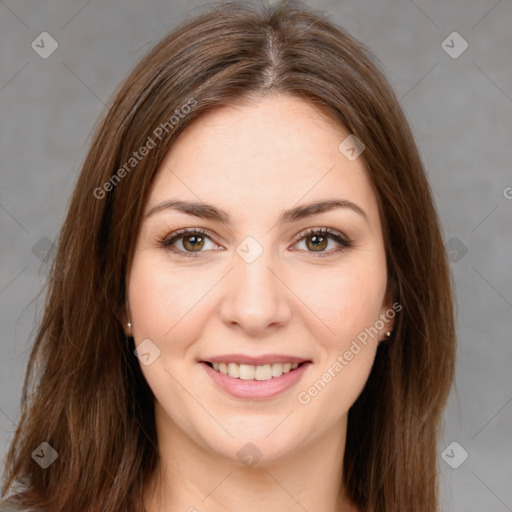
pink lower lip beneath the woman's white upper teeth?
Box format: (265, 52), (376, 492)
(201, 363), (311, 400)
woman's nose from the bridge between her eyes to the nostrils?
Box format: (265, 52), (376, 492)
(222, 236), (290, 332)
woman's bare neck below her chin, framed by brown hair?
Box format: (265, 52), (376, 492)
(144, 403), (357, 512)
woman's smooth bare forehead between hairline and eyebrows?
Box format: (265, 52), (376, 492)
(146, 95), (378, 228)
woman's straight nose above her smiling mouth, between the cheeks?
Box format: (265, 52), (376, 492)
(220, 243), (293, 337)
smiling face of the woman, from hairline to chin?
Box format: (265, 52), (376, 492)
(127, 95), (394, 462)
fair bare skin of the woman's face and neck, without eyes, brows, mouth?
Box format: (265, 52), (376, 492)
(125, 94), (392, 512)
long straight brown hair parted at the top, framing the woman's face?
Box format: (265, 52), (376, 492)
(2, 2), (455, 512)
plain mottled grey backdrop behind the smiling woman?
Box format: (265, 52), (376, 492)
(0, 0), (512, 512)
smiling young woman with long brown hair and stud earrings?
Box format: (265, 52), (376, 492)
(2, 2), (455, 512)
